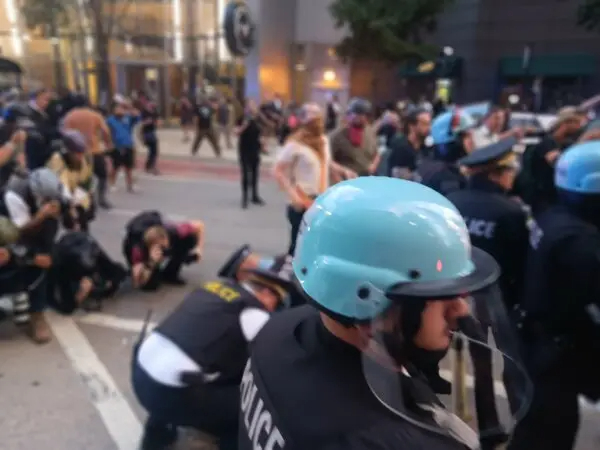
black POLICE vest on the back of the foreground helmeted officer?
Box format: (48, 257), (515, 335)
(239, 306), (465, 450)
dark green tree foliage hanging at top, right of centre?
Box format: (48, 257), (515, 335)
(329, 0), (453, 62)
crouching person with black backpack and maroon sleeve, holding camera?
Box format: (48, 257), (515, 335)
(123, 211), (205, 291)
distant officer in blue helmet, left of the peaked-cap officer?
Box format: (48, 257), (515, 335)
(417, 108), (476, 195)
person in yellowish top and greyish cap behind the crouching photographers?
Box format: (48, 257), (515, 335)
(48, 130), (94, 231)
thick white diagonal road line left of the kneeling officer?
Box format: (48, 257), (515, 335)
(46, 312), (142, 450)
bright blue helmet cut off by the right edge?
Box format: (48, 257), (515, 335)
(554, 141), (600, 194)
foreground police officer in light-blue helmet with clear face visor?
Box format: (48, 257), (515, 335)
(240, 177), (528, 450)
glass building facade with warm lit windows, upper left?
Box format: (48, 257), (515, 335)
(0, 0), (243, 110)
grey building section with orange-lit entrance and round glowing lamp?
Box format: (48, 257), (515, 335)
(245, 0), (350, 104)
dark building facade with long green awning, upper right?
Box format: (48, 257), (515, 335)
(428, 0), (600, 107)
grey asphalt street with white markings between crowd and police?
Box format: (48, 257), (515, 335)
(0, 160), (600, 450)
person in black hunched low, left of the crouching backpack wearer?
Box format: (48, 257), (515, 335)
(49, 231), (129, 314)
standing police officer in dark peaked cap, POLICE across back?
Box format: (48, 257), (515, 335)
(448, 137), (529, 307)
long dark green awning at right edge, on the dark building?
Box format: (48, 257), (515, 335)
(500, 54), (597, 77)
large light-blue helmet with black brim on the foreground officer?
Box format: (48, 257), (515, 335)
(292, 177), (499, 321)
